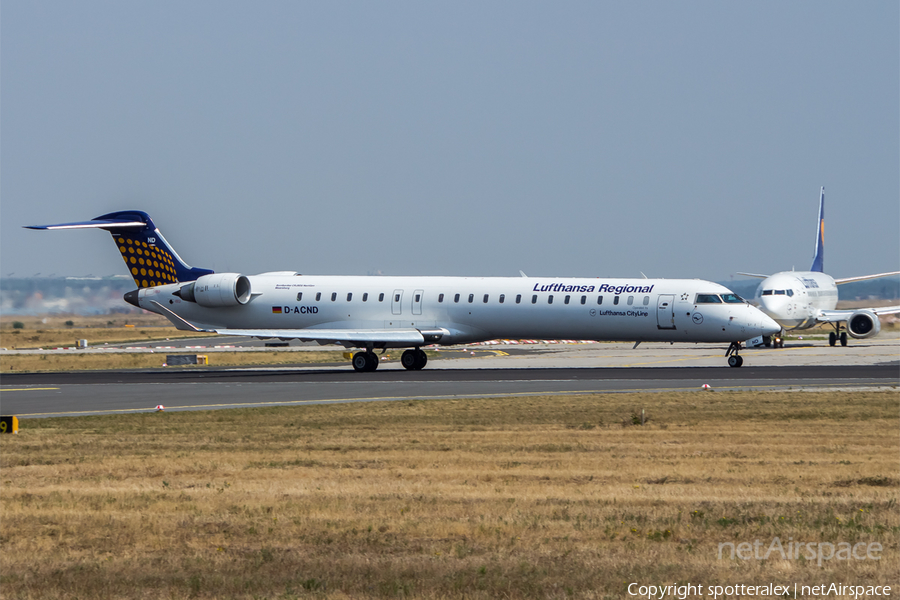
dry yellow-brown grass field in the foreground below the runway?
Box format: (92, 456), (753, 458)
(0, 391), (900, 599)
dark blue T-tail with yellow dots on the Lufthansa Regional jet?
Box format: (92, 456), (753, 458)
(27, 210), (214, 288)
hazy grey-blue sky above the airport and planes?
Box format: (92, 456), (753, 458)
(0, 0), (900, 281)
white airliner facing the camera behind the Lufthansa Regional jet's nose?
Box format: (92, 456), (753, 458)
(739, 187), (900, 348)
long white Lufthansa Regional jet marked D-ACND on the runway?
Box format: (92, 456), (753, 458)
(29, 211), (781, 371)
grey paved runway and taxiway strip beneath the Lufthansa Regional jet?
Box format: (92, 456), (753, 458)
(0, 334), (900, 418)
